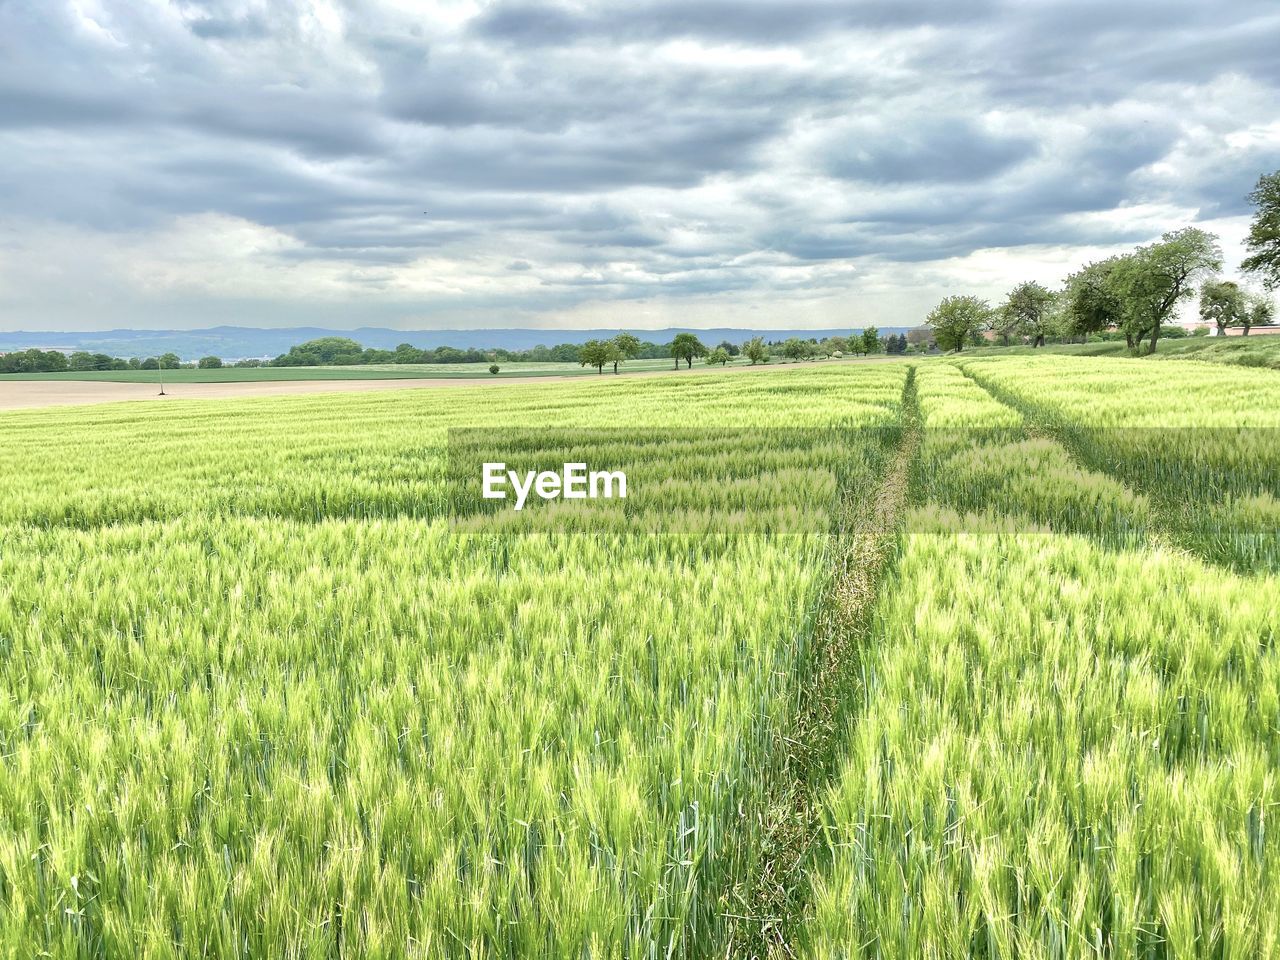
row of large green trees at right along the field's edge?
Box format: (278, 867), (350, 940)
(925, 172), (1280, 353)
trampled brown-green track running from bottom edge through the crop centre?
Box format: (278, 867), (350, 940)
(717, 366), (920, 960)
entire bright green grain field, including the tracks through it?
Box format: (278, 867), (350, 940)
(0, 355), (1280, 960)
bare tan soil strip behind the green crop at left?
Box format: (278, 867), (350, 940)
(0, 357), (895, 410)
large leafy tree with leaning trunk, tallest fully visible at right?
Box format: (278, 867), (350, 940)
(1111, 227), (1222, 353)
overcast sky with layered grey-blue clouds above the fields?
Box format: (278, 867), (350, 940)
(0, 0), (1280, 330)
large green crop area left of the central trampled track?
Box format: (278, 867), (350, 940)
(0, 366), (906, 957)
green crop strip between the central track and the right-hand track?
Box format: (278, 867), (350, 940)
(804, 365), (1280, 960)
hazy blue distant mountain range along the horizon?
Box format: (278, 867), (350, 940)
(0, 326), (909, 360)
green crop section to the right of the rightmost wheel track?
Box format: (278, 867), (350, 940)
(961, 358), (1280, 573)
